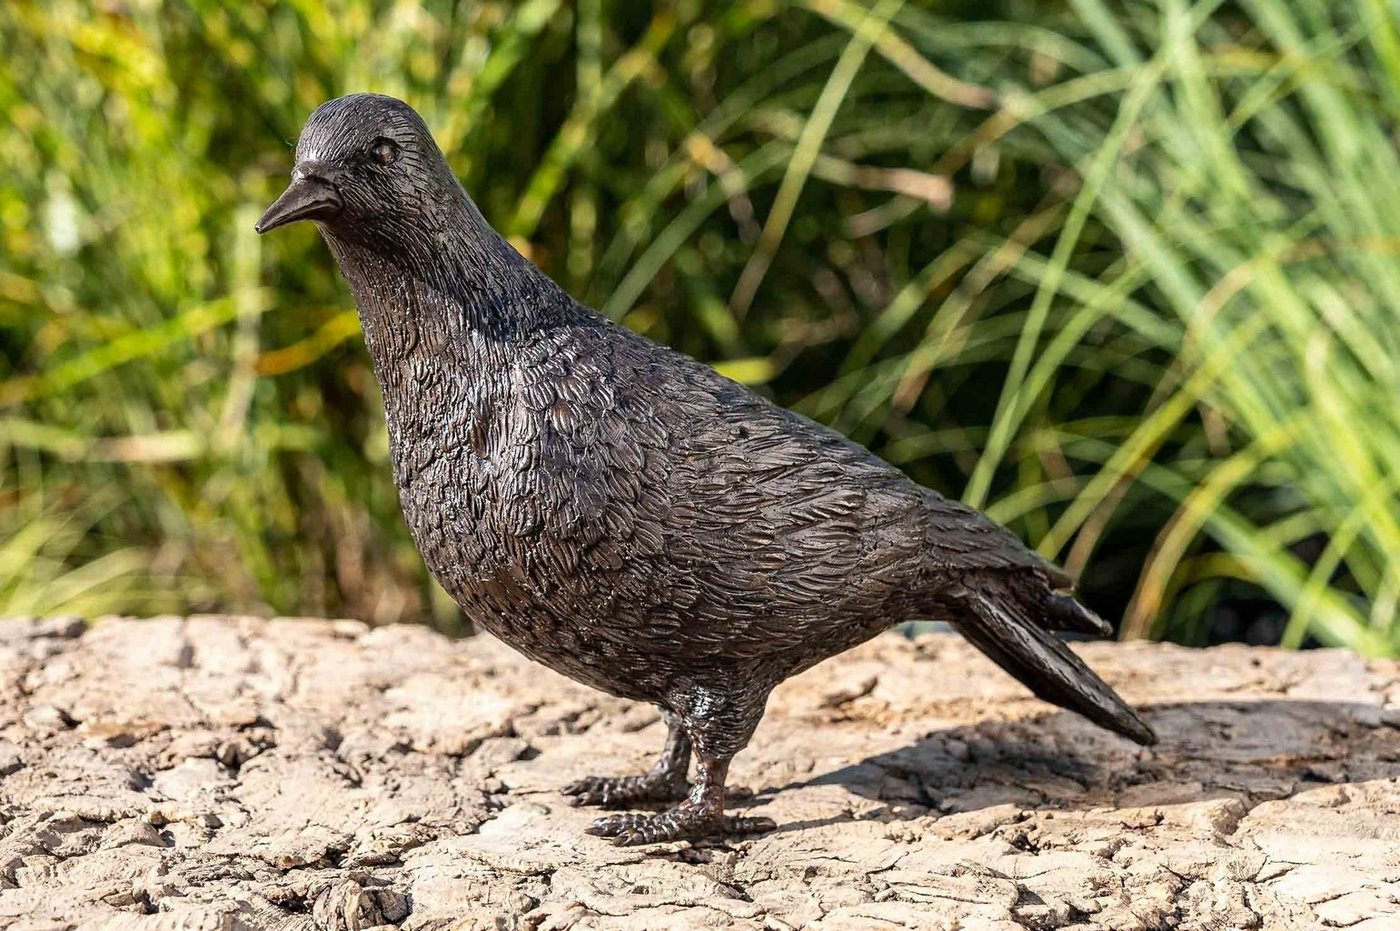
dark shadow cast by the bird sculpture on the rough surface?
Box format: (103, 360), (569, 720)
(778, 700), (1400, 830)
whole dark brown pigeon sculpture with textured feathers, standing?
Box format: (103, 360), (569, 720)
(258, 94), (1155, 844)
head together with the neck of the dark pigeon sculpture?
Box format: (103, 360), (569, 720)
(255, 94), (565, 341)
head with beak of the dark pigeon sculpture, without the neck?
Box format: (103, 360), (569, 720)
(255, 94), (466, 246)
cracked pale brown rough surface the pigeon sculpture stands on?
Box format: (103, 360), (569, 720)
(0, 617), (1400, 931)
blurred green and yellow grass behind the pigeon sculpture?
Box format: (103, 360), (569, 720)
(0, 0), (1400, 654)
